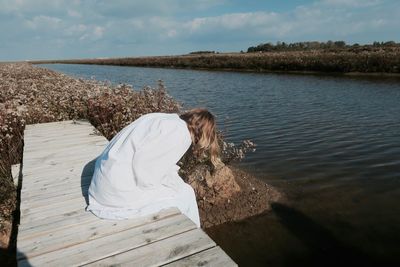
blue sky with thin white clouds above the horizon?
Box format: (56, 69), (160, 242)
(0, 0), (400, 61)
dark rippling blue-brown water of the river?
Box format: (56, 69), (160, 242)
(39, 64), (400, 266)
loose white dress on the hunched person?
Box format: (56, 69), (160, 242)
(87, 113), (200, 227)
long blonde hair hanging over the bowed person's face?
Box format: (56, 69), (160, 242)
(180, 108), (221, 167)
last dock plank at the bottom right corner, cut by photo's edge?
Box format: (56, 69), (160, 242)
(164, 247), (237, 267)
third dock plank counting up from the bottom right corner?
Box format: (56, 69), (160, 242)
(19, 215), (196, 266)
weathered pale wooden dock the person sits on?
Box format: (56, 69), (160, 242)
(17, 121), (236, 266)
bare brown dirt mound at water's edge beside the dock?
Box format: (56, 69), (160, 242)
(187, 166), (283, 228)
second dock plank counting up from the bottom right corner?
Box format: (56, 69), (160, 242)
(88, 229), (215, 266)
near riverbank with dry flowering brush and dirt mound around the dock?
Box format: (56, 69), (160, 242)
(0, 63), (281, 262)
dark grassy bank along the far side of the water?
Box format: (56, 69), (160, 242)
(32, 47), (400, 74)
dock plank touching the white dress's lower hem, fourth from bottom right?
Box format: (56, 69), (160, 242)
(17, 208), (181, 259)
